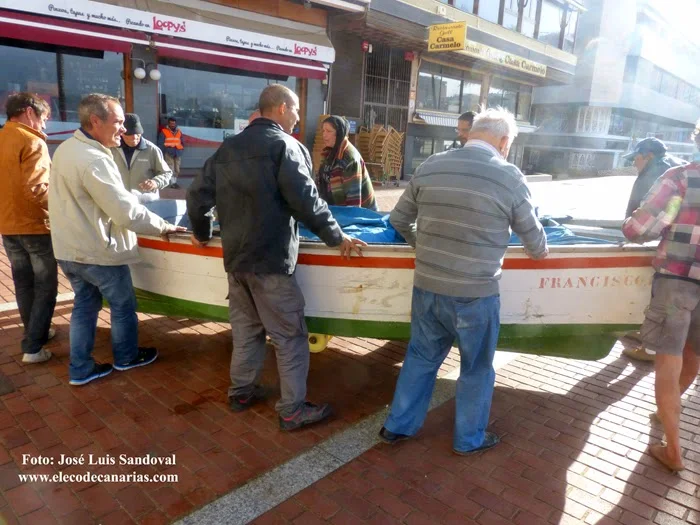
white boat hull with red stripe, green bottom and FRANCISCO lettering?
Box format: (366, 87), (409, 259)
(132, 199), (655, 359)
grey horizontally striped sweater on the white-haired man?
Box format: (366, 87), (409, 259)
(390, 144), (547, 297)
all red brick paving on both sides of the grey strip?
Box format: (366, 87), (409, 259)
(5, 244), (700, 525)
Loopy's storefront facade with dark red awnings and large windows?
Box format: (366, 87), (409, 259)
(0, 0), (368, 168)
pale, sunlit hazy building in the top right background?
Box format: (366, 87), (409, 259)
(524, 0), (700, 176)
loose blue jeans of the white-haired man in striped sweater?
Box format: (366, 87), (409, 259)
(384, 287), (501, 452)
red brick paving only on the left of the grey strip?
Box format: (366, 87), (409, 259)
(0, 246), (457, 525)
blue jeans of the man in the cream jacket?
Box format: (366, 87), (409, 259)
(58, 261), (138, 379)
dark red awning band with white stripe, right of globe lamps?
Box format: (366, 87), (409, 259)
(153, 35), (327, 80)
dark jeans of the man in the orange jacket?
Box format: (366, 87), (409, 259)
(2, 234), (58, 354)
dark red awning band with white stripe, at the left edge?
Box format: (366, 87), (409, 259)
(0, 11), (148, 53)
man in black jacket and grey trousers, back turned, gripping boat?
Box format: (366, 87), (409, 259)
(187, 84), (364, 430)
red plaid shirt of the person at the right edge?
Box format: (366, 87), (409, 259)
(622, 162), (700, 281)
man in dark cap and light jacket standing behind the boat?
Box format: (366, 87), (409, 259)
(111, 113), (173, 202)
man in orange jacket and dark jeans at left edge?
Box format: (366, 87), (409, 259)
(0, 93), (58, 363)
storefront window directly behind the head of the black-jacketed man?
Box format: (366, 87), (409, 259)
(158, 61), (296, 142)
